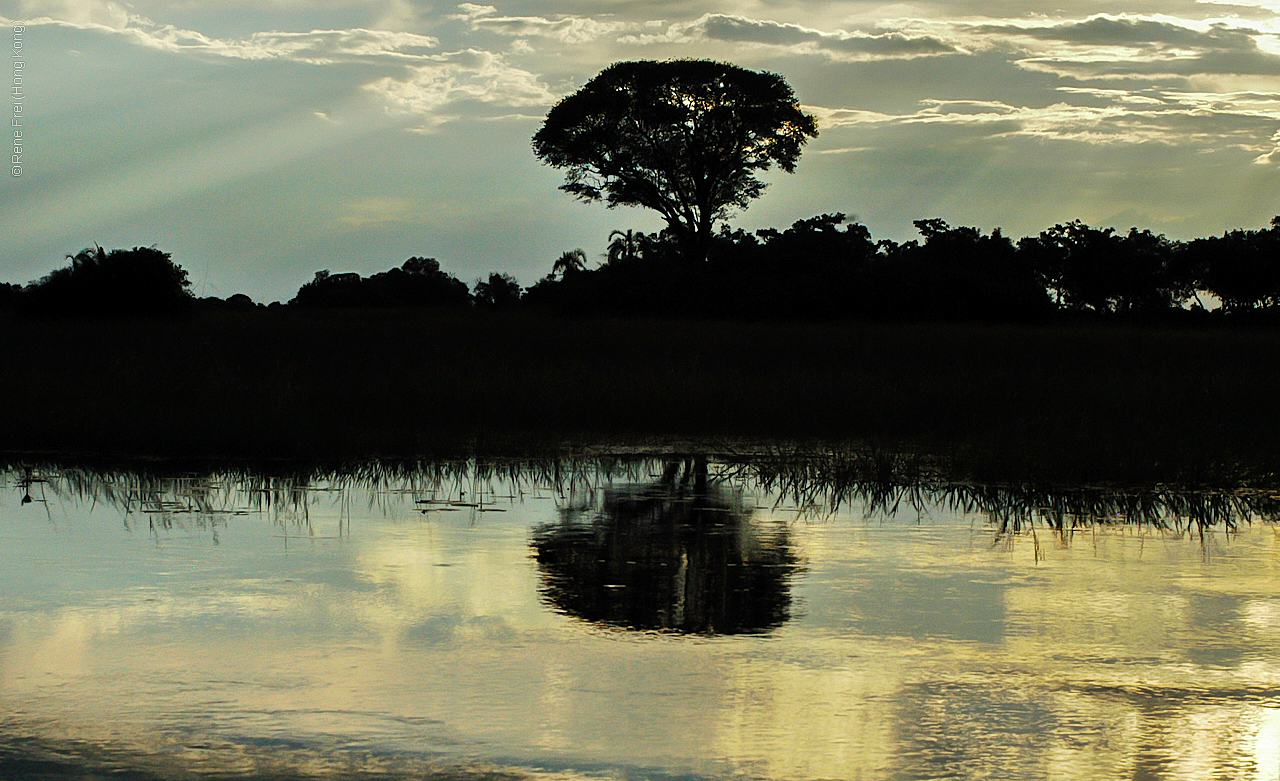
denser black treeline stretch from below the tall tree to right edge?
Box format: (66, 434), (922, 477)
(522, 214), (1280, 321)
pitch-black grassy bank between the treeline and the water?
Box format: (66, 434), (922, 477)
(0, 310), (1280, 479)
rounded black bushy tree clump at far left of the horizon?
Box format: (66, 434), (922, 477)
(22, 246), (193, 316)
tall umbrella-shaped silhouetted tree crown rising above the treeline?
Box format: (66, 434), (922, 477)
(534, 60), (818, 259)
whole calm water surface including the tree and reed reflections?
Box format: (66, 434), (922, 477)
(0, 456), (1280, 780)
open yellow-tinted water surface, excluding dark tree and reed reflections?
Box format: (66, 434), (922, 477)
(0, 466), (1280, 781)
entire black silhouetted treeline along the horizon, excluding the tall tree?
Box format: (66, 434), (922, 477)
(0, 214), (1280, 321)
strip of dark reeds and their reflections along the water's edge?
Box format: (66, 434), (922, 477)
(10, 448), (1280, 547)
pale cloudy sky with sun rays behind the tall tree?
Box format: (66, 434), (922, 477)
(0, 0), (1280, 301)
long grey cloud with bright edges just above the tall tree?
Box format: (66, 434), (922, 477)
(622, 14), (957, 59)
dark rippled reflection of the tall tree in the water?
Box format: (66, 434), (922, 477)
(532, 457), (796, 634)
